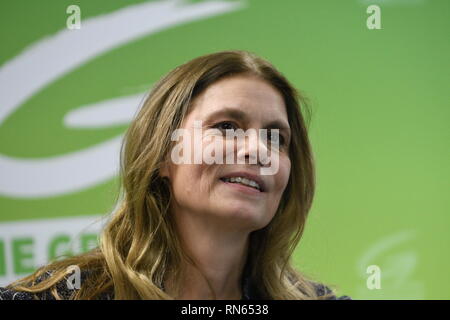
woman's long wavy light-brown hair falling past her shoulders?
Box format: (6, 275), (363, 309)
(8, 51), (338, 299)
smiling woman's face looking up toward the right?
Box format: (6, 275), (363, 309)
(161, 75), (291, 232)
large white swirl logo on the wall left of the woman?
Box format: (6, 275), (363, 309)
(0, 0), (243, 198)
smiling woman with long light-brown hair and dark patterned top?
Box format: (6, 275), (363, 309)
(0, 51), (348, 299)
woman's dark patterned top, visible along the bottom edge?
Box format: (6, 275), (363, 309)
(0, 272), (352, 300)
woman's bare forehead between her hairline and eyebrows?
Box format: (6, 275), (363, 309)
(190, 75), (287, 122)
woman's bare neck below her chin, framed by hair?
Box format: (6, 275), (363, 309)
(165, 209), (249, 300)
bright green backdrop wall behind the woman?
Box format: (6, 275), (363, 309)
(0, 0), (450, 299)
